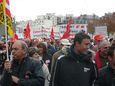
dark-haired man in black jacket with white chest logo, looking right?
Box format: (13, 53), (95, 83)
(50, 33), (97, 86)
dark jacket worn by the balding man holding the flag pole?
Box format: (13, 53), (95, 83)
(1, 57), (44, 86)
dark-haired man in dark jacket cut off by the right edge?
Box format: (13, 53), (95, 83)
(96, 46), (115, 86)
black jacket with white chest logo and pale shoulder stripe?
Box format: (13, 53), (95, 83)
(50, 47), (97, 86)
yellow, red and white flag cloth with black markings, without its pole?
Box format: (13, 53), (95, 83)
(0, 0), (14, 37)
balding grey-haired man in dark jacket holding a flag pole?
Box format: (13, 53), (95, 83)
(1, 40), (44, 86)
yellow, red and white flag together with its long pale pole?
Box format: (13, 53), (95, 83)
(0, 0), (14, 60)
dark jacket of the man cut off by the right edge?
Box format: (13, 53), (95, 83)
(96, 65), (115, 86)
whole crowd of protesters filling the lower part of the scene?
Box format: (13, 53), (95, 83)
(0, 32), (115, 86)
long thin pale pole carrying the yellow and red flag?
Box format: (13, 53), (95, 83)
(3, 0), (10, 60)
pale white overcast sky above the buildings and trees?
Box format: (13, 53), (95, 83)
(9, 0), (115, 21)
